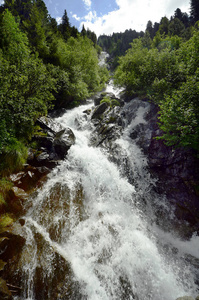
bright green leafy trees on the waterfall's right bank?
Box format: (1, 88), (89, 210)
(115, 28), (199, 151)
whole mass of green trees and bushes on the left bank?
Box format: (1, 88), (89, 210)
(0, 4), (109, 176)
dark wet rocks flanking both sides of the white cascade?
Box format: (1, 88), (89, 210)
(0, 93), (199, 299)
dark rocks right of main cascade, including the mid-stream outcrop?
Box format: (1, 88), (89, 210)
(90, 98), (199, 232)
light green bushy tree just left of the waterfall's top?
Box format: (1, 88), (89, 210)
(51, 36), (107, 101)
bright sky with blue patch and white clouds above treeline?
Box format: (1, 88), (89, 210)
(0, 0), (190, 36)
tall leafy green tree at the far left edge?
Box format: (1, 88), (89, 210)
(0, 10), (55, 144)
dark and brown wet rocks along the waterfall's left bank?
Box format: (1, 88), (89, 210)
(0, 113), (75, 299)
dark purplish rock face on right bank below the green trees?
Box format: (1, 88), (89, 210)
(123, 99), (199, 231)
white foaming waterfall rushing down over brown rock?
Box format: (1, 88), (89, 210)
(16, 82), (199, 300)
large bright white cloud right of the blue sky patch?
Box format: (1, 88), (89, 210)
(80, 0), (190, 36)
